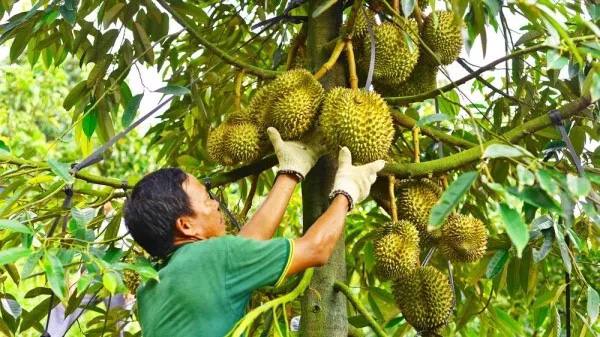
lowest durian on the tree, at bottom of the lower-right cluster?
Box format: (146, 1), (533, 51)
(393, 266), (453, 332)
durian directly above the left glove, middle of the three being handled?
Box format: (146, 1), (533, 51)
(265, 69), (324, 140)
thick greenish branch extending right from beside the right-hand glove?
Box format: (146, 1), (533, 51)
(381, 96), (591, 177)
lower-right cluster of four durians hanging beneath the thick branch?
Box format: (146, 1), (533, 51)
(371, 179), (487, 336)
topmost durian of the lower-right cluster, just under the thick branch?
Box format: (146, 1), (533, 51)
(396, 179), (442, 245)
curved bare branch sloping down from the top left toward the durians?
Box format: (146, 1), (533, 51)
(158, 0), (279, 78)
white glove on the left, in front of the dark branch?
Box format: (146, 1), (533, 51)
(267, 127), (325, 181)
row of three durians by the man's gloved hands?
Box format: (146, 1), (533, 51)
(207, 68), (394, 165)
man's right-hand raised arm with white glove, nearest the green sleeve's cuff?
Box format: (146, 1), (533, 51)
(287, 147), (385, 275)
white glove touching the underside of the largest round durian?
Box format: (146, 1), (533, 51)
(329, 146), (385, 210)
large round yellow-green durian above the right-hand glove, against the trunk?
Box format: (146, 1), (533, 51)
(319, 87), (394, 163)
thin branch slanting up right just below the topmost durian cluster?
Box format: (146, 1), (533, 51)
(385, 35), (594, 105)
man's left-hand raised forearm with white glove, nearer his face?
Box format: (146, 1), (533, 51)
(238, 127), (323, 240)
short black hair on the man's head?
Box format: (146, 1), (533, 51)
(124, 168), (194, 258)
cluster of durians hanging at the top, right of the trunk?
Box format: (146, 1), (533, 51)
(353, 5), (463, 96)
